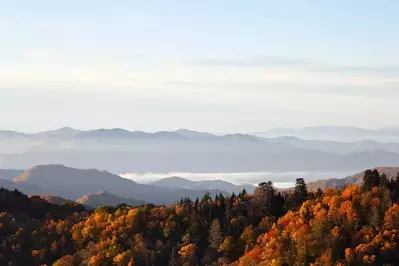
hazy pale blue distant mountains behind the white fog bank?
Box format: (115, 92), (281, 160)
(0, 127), (399, 173)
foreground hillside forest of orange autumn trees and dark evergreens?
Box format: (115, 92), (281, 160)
(0, 170), (399, 266)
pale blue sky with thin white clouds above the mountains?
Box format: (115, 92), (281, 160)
(0, 0), (399, 132)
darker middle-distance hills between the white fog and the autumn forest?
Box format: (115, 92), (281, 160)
(0, 165), (399, 207)
